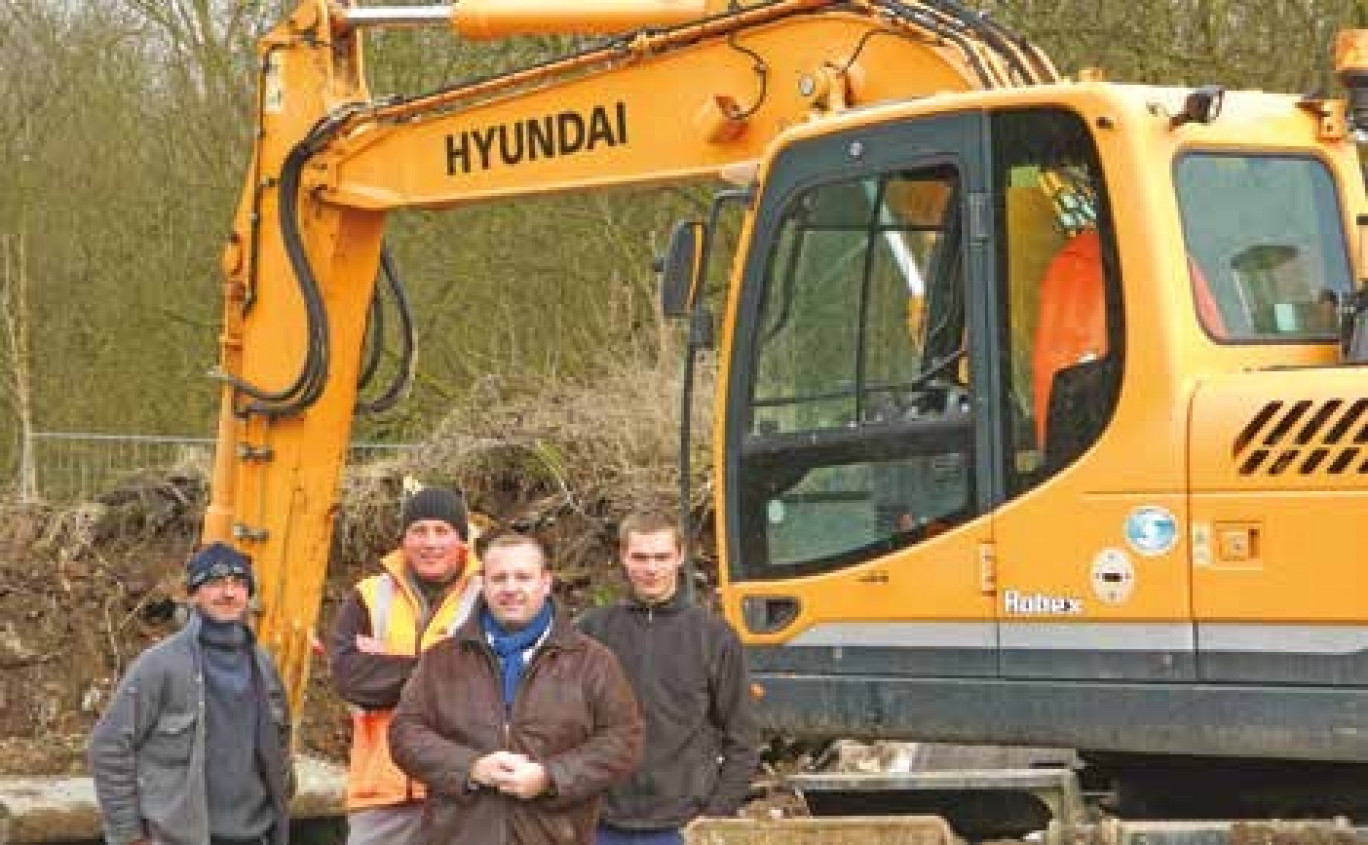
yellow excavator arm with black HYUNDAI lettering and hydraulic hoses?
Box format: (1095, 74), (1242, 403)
(204, 0), (1056, 706)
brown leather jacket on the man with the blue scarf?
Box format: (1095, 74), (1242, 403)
(390, 601), (643, 845)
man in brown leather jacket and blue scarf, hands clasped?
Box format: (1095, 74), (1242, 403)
(390, 535), (643, 845)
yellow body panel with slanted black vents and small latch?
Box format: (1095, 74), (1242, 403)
(1192, 369), (1368, 622)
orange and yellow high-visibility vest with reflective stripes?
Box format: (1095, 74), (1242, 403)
(346, 551), (480, 812)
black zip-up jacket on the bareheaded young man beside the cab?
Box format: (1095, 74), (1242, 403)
(579, 593), (759, 830)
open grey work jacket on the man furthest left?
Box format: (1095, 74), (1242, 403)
(88, 613), (294, 845)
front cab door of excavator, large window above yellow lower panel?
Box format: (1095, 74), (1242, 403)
(718, 112), (999, 678)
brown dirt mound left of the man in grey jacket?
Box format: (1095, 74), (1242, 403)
(0, 473), (204, 774)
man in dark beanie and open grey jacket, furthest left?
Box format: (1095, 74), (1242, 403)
(89, 543), (294, 845)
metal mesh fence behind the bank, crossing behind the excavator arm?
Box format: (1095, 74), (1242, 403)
(31, 431), (413, 502)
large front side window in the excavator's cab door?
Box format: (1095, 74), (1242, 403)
(740, 164), (974, 574)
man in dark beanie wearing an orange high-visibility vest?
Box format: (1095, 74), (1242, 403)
(328, 487), (480, 845)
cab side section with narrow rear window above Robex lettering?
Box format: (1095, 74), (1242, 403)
(992, 108), (1196, 680)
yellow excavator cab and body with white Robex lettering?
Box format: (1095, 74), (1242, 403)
(672, 83), (1368, 762)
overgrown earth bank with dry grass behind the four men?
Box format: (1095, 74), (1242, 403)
(0, 358), (711, 774)
